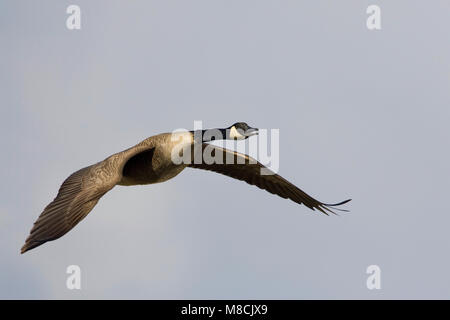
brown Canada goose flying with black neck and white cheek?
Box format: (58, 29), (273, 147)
(21, 122), (351, 253)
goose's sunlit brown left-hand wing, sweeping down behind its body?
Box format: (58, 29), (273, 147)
(21, 163), (115, 253)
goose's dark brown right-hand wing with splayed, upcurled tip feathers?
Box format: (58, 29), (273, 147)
(189, 143), (351, 215)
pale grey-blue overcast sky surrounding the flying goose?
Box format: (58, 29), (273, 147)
(0, 0), (450, 299)
